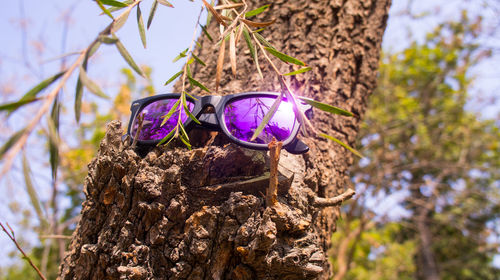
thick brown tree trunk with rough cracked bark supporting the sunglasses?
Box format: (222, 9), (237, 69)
(56, 0), (390, 279)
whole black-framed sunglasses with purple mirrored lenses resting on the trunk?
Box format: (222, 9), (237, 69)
(127, 92), (312, 154)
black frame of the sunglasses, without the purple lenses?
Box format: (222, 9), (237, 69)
(127, 92), (312, 154)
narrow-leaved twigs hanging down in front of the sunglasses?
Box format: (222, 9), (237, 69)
(159, 0), (363, 157)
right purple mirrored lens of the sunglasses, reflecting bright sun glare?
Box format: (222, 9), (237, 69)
(224, 97), (296, 144)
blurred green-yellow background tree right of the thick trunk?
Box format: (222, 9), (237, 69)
(332, 12), (500, 279)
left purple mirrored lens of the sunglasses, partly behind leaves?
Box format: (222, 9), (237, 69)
(130, 99), (194, 141)
